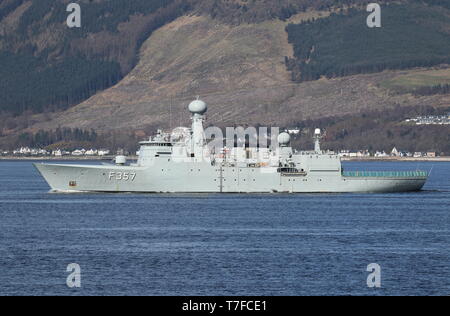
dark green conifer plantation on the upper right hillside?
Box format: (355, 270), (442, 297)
(286, 0), (450, 82)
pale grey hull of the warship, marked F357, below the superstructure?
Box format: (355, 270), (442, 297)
(35, 163), (427, 193)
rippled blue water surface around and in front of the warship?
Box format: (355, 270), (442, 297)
(0, 161), (450, 295)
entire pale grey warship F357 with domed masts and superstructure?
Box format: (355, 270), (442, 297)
(35, 100), (428, 193)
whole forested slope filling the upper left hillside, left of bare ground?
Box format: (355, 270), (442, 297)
(0, 0), (188, 115)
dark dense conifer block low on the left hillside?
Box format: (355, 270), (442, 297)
(0, 52), (122, 115)
